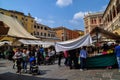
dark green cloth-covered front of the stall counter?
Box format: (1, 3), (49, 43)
(86, 54), (117, 68)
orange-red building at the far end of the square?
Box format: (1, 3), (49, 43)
(53, 26), (80, 41)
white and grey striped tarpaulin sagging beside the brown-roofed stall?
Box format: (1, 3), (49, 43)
(55, 34), (92, 52)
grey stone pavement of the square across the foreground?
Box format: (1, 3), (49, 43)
(0, 60), (120, 80)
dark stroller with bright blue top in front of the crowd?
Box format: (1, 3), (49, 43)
(29, 56), (40, 75)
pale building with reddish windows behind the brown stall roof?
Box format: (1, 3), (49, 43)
(84, 12), (103, 34)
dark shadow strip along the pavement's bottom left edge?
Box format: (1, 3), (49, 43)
(0, 72), (67, 80)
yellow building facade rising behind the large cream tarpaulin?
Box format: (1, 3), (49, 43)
(0, 8), (34, 34)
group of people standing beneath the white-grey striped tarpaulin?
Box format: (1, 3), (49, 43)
(58, 46), (88, 71)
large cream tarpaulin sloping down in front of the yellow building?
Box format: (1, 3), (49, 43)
(0, 14), (37, 39)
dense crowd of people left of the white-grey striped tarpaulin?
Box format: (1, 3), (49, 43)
(1, 45), (55, 73)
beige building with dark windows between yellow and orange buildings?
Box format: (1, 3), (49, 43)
(33, 22), (60, 42)
